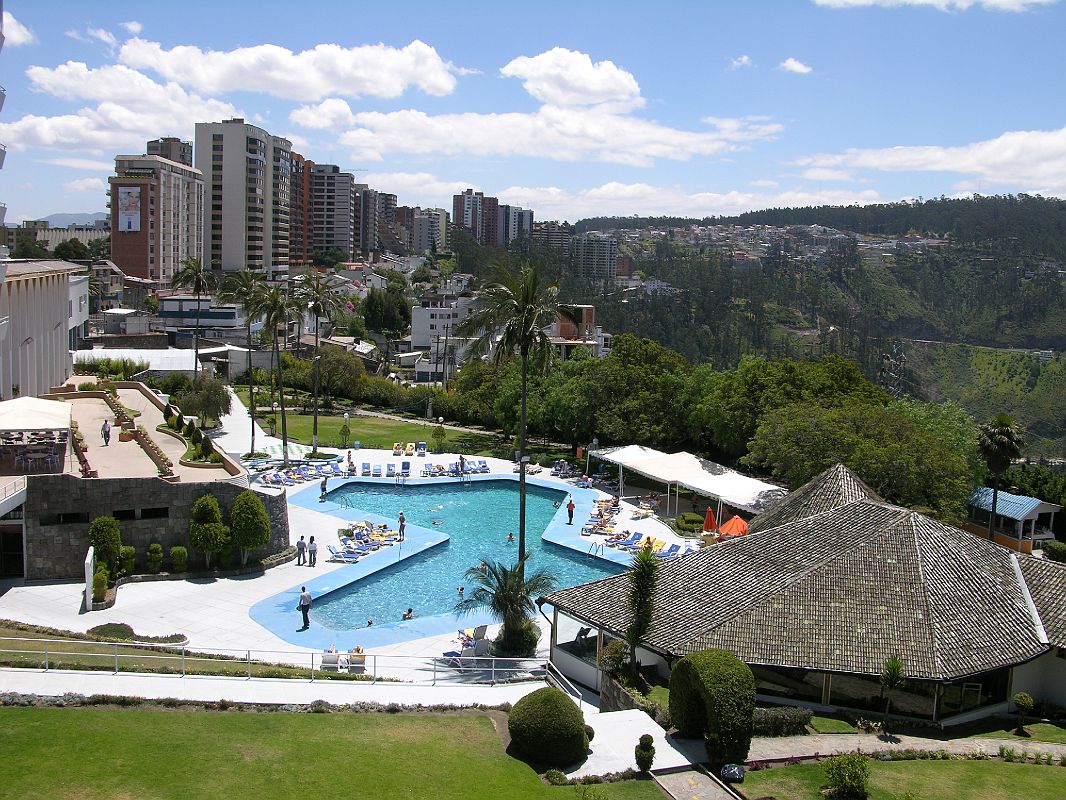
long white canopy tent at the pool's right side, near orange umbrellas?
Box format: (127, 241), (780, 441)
(592, 445), (788, 517)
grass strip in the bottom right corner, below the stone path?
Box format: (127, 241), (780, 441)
(743, 762), (1066, 800)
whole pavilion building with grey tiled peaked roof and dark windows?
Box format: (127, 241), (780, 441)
(539, 465), (1066, 725)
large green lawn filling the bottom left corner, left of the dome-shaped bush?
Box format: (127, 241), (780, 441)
(0, 708), (660, 800)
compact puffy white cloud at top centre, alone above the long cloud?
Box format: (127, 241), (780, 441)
(500, 47), (644, 111)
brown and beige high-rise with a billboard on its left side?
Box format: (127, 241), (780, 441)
(108, 144), (204, 288)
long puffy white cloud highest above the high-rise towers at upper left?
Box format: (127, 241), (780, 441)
(118, 38), (455, 100)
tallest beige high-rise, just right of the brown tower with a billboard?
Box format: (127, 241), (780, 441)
(195, 117), (292, 274)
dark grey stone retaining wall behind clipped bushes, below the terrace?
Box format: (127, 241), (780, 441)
(25, 475), (289, 580)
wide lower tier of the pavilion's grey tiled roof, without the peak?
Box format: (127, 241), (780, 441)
(545, 501), (1047, 679)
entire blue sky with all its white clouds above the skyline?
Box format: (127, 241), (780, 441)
(0, 0), (1066, 222)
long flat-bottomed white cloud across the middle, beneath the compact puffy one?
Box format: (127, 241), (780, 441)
(300, 100), (781, 166)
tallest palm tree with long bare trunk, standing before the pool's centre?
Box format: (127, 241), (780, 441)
(454, 263), (580, 570)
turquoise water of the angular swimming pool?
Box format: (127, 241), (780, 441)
(314, 480), (623, 630)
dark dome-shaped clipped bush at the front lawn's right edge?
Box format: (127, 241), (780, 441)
(507, 686), (588, 768)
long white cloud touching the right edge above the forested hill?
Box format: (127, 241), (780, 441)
(797, 128), (1066, 196)
